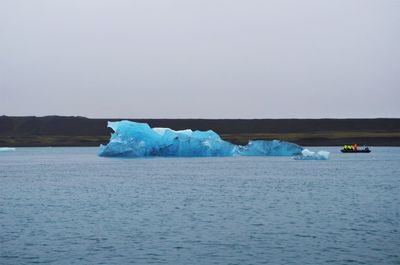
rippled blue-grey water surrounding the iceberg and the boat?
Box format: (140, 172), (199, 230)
(0, 147), (400, 265)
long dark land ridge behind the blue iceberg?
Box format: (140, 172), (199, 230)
(0, 116), (400, 147)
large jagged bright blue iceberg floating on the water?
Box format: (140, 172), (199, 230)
(99, 121), (326, 157)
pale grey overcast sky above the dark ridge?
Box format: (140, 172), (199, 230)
(0, 0), (400, 118)
